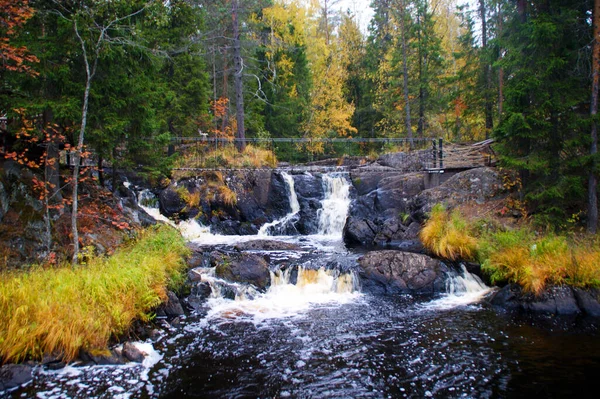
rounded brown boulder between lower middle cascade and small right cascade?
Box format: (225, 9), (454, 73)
(359, 250), (448, 295)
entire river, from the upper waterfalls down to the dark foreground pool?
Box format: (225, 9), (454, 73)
(7, 176), (600, 399)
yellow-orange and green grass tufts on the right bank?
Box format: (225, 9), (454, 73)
(421, 205), (600, 294)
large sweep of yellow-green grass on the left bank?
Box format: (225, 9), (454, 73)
(0, 226), (187, 362)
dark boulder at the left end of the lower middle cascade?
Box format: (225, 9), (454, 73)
(211, 253), (271, 290)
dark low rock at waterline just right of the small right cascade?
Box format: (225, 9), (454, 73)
(489, 284), (581, 315)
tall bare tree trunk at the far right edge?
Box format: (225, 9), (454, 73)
(587, 0), (600, 234)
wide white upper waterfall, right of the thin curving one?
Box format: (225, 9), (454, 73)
(319, 175), (350, 237)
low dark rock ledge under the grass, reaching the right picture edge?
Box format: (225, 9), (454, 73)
(489, 284), (600, 317)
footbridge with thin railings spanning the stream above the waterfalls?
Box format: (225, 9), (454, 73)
(168, 137), (496, 174)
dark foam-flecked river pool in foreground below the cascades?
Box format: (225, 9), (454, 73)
(11, 282), (600, 398)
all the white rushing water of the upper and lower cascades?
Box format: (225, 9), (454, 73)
(138, 172), (489, 321)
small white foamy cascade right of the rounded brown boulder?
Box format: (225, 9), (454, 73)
(421, 265), (492, 310)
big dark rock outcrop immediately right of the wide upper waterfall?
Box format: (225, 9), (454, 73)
(344, 165), (503, 247)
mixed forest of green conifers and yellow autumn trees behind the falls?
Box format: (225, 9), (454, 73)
(0, 0), (598, 232)
